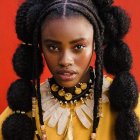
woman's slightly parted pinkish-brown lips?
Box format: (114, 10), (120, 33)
(56, 70), (78, 81)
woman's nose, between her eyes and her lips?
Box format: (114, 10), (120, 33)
(59, 51), (74, 67)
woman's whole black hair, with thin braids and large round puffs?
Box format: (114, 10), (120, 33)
(2, 0), (140, 140)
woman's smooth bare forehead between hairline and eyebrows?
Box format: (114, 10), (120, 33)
(41, 16), (94, 39)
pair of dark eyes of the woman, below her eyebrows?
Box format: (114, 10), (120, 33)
(47, 44), (86, 52)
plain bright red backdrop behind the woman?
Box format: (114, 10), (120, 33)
(0, 0), (140, 113)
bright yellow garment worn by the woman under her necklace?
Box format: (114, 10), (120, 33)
(0, 78), (140, 140)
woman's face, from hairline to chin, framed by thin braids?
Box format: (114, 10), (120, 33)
(41, 16), (94, 87)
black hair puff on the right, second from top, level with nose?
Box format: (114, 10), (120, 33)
(103, 41), (132, 75)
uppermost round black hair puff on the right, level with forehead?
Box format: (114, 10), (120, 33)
(100, 6), (131, 43)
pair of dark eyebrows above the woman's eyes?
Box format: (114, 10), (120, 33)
(44, 38), (86, 44)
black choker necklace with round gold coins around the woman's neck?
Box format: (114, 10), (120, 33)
(49, 78), (93, 103)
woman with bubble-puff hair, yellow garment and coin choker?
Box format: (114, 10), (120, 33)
(0, 0), (140, 140)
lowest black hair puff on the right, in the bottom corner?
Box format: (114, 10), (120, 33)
(115, 111), (140, 140)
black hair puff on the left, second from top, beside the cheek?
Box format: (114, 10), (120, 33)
(12, 44), (44, 80)
